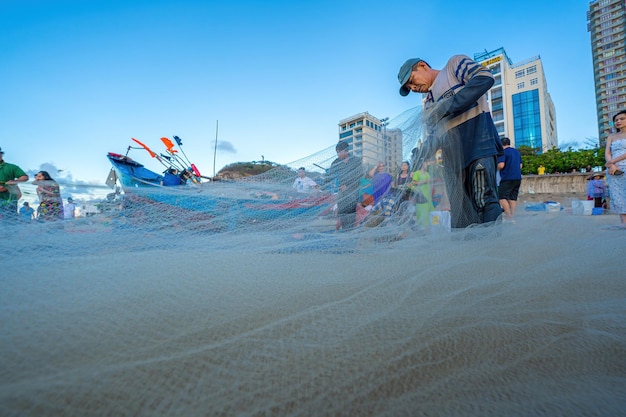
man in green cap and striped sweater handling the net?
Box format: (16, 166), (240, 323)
(398, 55), (502, 228)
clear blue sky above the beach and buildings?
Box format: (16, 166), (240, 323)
(0, 0), (598, 184)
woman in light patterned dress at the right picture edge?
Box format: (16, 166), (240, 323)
(604, 110), (626, 227)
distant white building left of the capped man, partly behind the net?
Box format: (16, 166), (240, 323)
(339, 112), (402, 175)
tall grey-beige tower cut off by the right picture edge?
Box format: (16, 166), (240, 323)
(587, 0), (626, 147)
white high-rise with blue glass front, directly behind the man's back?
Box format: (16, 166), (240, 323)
(474, 48), (558, 153)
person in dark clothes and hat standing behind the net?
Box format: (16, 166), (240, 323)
(326, 141), (364, 230)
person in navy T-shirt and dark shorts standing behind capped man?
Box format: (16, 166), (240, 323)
(498, 138), (522, 221)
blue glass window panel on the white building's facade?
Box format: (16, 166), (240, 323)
(512, 89), (543, 150)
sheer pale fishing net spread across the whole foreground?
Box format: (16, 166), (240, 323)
(0, 105), (626, 416)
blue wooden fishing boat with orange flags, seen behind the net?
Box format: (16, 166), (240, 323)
(107, 140), (335, 230)
